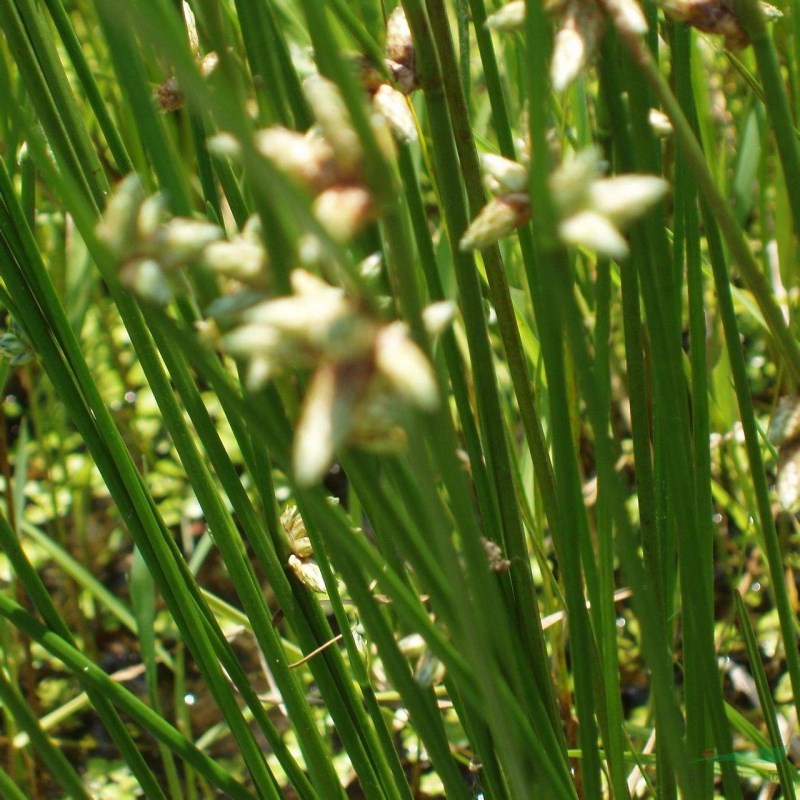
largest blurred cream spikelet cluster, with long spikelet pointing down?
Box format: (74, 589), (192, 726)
(219, 269), (442, 485)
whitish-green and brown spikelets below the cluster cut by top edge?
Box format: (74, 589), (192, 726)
(460, 147), (668, 258)
